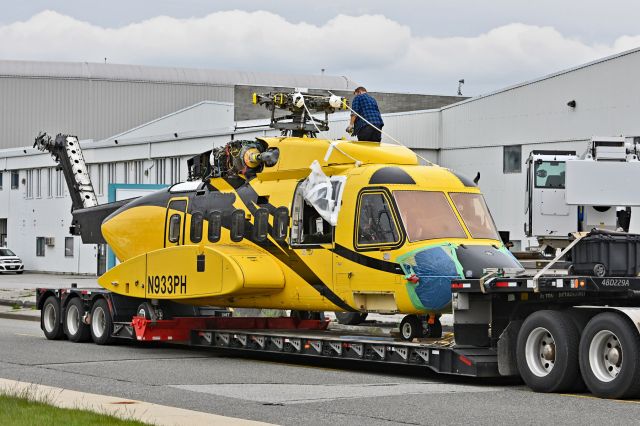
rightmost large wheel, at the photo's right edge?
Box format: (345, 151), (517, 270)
(580, 312), (640, 398)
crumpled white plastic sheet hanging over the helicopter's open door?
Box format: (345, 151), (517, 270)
(301, 160), (347, 226)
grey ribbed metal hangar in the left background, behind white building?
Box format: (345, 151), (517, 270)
(0, 77), (233, 149)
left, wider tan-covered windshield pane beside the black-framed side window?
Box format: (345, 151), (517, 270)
(393, 191), (467, 242)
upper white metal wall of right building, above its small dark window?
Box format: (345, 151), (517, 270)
(442, 52), (640, 148)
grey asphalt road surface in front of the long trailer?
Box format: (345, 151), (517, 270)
(0, 319), (640, 425)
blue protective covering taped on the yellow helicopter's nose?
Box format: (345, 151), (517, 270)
(401, 246), (460, 311)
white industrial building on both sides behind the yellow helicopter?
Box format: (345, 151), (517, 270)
(0, 49), (640, 273)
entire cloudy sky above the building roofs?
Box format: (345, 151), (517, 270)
(0, 0), (640, 96)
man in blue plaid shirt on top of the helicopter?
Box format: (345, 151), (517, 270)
(347, 86), (384, 142)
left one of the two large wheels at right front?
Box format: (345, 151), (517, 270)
(516, 310), (580, 392)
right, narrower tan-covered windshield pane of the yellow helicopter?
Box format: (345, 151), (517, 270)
(449, 192), (500, 240)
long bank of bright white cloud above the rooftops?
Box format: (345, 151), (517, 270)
(0, 10), (640, 94)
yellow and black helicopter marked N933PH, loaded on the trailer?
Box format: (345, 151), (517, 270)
(36, 93), (521, 338)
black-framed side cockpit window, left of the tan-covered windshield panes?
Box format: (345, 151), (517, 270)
(357, 193), (400, 246)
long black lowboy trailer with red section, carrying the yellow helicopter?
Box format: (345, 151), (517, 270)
(37, 271), (640, 398)
